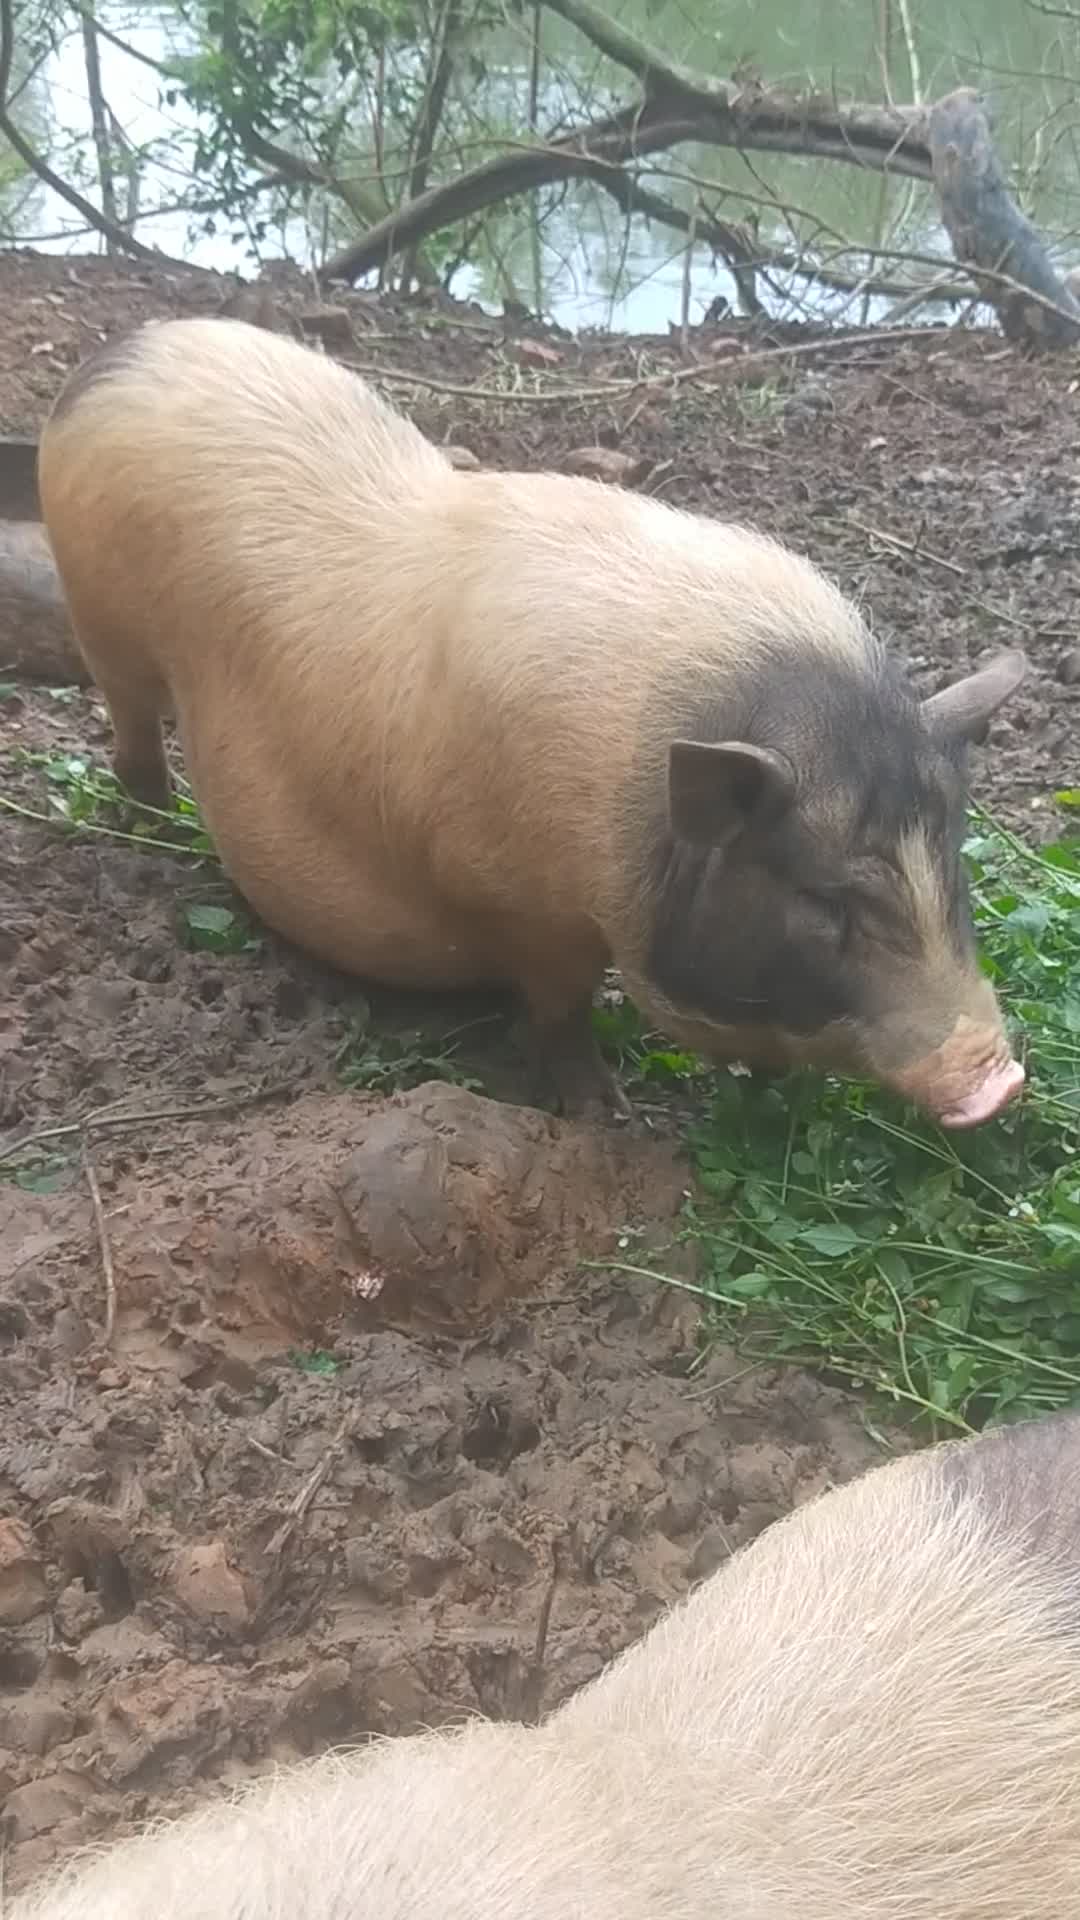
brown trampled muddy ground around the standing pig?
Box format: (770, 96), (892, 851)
(0, 252), (1080, 1885)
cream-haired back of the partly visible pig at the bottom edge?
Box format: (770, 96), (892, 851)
(6, 1413), (1080, 1920)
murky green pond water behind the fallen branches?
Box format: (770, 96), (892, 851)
(8, 0), (1080, 332)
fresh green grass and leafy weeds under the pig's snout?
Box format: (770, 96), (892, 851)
(8, 755), (1080, 1430)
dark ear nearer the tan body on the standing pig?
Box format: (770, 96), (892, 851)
(667, 739), (796, 847)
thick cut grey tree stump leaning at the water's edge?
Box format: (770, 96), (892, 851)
(928, 86), (1080, 346)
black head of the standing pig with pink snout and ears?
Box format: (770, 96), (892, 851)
(630, 653), (1024, 1127)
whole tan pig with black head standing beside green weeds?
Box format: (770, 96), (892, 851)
(38, 319), (1024, 1127)
